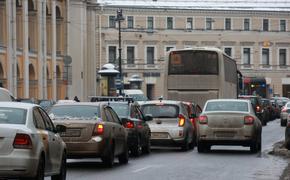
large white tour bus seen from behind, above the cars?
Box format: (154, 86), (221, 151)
(164, 47), (238, 107)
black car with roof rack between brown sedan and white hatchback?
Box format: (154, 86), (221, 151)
(91, 97), (152, 157)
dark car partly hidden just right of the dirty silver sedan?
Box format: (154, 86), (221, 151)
(238, 95), (269, 126)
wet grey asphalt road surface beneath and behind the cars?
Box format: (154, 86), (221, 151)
(50, 119), (288, 180)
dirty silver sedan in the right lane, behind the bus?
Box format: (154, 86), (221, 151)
(197, 99), (262, 153)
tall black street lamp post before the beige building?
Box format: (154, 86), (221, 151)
(115, 9), (124, 95)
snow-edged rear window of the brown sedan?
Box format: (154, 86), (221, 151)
(49, 105), (100, 119)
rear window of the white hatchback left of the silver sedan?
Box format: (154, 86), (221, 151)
(141, 104), (179, 118)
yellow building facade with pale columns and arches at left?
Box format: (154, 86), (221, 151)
(0, 0), (68, 100)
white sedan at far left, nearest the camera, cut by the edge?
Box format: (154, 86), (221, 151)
(0, 102), (66, 180)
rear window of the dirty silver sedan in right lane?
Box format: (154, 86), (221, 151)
(205, 101), (249, 112)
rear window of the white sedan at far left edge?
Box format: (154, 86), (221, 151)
(0, 107), (27, 124)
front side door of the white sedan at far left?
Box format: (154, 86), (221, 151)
(39, 108), (63, 172)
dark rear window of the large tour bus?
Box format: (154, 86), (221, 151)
(168, 50), (218, 75)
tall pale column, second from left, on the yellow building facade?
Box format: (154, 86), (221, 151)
(22, 0), (29, 98)
